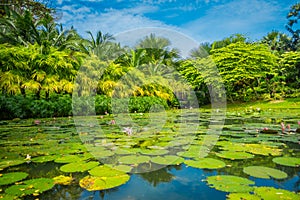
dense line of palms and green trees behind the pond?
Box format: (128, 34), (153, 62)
(0, 0), (300, 119)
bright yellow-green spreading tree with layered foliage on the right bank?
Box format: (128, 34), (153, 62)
(212, 42), (278, 101)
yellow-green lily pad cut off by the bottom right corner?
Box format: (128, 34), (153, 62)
(254, 187), (300, 200)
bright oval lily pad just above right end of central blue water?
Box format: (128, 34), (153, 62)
(184, 158), (226, 169)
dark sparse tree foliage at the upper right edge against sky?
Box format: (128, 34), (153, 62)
(285, 3), (300, 51)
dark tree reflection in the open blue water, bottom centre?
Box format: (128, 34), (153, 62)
(139, 165), (181, 187)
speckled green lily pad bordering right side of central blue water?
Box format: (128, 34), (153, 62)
(207, 175), (254, 193)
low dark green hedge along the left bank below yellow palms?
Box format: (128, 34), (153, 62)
(0, 94), (169, 119)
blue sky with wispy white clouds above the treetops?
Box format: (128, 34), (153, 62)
(52, 0), (297, 43)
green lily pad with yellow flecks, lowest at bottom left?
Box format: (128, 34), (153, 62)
(5, 178), (55, 197)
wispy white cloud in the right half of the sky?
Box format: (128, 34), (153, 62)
(182, 0), (285, 41)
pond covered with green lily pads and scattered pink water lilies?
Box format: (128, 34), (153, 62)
(0, 109), (300, 200)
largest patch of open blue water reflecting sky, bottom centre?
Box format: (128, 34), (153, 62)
(81, 165), (226, 200)
